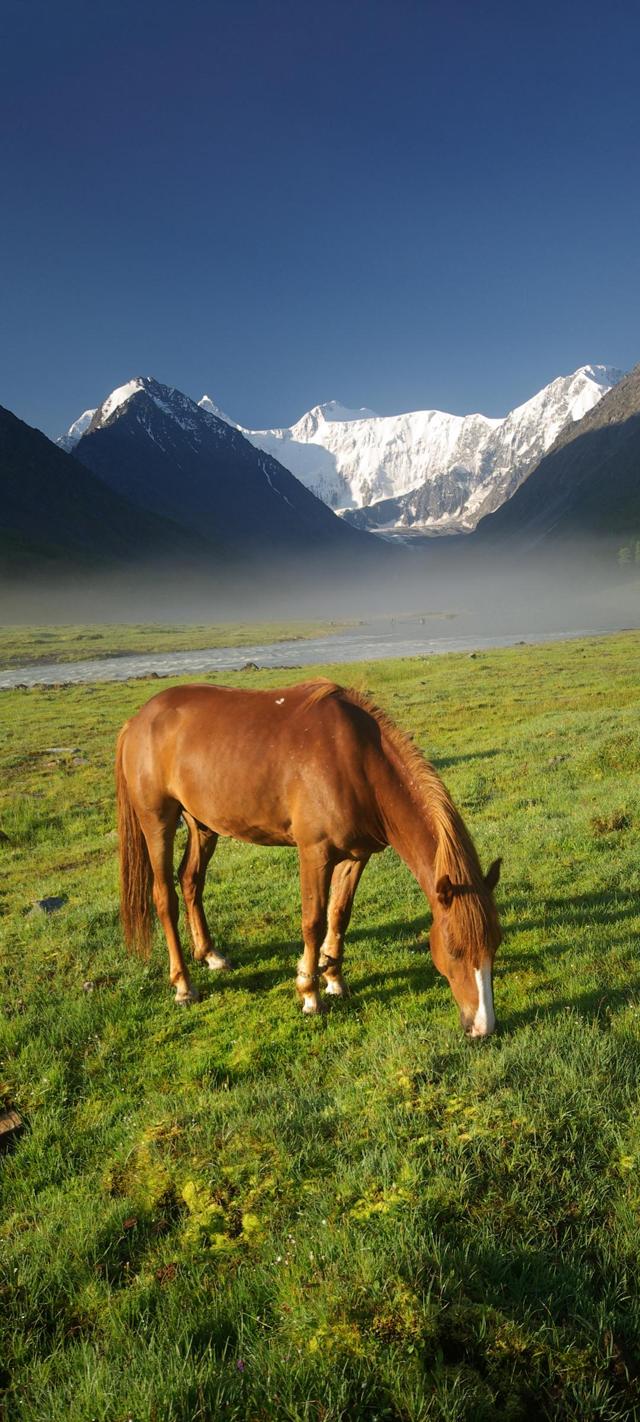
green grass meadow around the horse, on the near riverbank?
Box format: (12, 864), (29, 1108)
(0, 633), (640, 1422)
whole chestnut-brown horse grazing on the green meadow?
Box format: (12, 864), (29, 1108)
(117, 681), (501, 1037)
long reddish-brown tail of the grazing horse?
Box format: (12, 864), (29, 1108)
(115, 725), (154, 958)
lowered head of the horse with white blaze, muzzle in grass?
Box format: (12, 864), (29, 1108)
(430, 859), (502, 1037)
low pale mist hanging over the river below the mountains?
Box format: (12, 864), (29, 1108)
(0, 539), (640, 648)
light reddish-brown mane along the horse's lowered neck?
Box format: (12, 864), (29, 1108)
(304, 680), (495, 961)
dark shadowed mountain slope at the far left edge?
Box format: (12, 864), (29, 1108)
(0, 407), (205, 573)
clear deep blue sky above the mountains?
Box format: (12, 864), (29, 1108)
(0, 0), (640, 435)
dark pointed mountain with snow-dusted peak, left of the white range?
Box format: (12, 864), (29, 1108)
(75, 377), (377, 557)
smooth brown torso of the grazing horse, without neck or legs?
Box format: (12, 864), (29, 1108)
(118, 681), (384, 845)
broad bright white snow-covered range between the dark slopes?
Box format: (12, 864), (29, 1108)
(201, 365), (623, 533)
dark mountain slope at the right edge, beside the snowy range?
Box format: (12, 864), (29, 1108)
(468, 365), (640, 547)
